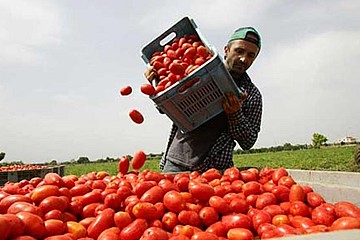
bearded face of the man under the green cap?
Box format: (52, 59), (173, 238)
(224, 39), (259, 78)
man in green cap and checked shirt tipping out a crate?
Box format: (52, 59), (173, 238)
(145, 27), (262, 172)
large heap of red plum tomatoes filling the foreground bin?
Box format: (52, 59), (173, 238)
(0, 167), (360, 240)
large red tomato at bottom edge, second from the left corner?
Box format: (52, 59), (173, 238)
(16, 212), (46, 239)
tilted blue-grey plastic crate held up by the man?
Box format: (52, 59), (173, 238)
(142, 17), (242, 132)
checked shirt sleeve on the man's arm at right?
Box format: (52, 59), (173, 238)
(228, 91), (262, 150)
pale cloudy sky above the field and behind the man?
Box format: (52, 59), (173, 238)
(0, 0), (360, 163)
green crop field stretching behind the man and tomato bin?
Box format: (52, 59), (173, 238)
(65, 146), (360, 176)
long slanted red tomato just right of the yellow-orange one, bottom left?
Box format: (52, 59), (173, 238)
(87, 208), (115, 239)
